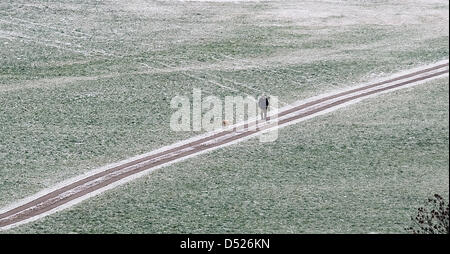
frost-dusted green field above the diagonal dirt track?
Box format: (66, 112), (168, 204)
(0, 0), (448, 230)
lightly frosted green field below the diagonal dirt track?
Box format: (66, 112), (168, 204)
(10, 78), (449, 233)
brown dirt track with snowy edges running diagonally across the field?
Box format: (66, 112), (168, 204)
(0, 62), (449, 229)
